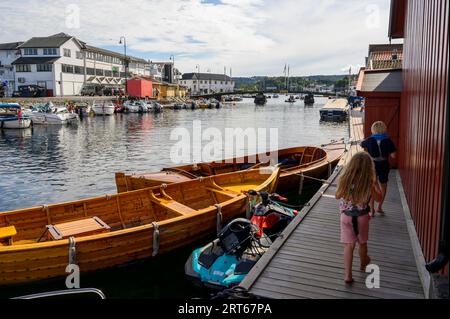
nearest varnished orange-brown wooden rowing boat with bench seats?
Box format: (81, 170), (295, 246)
(0, 168), (279, 285)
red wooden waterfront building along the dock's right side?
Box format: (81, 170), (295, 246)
(358, 0), (450, 275)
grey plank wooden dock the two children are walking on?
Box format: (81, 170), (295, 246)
(241, 111), (424, 299)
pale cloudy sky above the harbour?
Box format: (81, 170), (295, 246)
(0, 0), (398, 76)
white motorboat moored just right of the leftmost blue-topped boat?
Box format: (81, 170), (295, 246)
(24, 102), (79, 125)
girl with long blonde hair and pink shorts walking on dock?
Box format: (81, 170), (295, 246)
(336, 152), (381, 284)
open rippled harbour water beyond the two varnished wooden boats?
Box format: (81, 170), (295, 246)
(0, 97), (347, 211)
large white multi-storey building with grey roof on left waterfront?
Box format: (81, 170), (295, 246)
(0, 33), (155, 96)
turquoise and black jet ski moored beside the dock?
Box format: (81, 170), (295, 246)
(184, 218), (272, 289)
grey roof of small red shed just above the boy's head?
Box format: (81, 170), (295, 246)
(357, 69), (403, 93)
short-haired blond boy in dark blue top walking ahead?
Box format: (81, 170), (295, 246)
(361, 121), (397, 217)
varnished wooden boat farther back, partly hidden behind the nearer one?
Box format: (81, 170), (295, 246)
(116, 141), (345, 193)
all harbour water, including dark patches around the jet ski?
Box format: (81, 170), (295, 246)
(0, 96), (348, 298)
